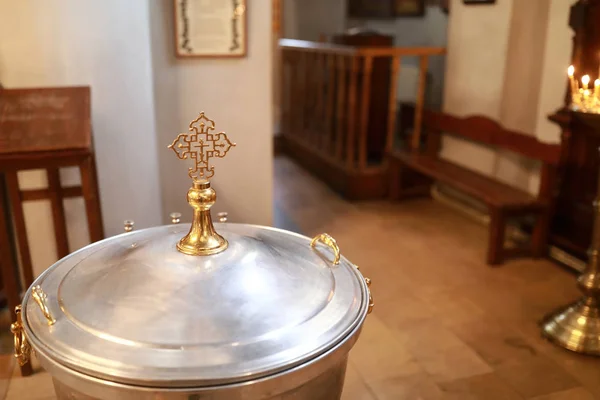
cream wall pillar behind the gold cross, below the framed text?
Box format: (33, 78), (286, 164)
(150, 0), (273, 225)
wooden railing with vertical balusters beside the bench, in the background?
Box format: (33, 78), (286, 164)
(279, 39), (445, 170)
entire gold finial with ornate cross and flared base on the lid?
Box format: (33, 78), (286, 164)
(169, 112), (235, 256)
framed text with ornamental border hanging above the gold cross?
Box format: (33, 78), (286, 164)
(173, 0), (247, 57)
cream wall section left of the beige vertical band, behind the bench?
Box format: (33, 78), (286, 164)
(442, 0), (512, 174)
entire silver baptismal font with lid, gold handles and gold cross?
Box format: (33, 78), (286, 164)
(12, 113), (373, 400)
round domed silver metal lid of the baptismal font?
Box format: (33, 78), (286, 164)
(23, 223), (369, 387)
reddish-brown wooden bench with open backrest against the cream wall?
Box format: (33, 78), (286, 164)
(388, 111), (562, 265)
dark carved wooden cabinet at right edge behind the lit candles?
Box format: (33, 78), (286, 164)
(550, 0), (600, 260)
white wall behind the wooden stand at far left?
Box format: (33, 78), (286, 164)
(0, 0), (162, 273)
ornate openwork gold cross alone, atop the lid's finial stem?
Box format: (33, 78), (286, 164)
(169, 112), (235, 182)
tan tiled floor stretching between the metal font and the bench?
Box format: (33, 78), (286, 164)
(0, 158), (600, 400)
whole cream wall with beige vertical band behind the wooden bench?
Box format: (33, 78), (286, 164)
(442, 0), (574, 193)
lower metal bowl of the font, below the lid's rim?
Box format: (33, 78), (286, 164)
(37, 316), (362, 400)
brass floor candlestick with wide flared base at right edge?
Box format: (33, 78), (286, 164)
(542, 158), (600, 356)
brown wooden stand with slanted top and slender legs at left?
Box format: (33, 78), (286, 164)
(0, 87), (104, 375)
